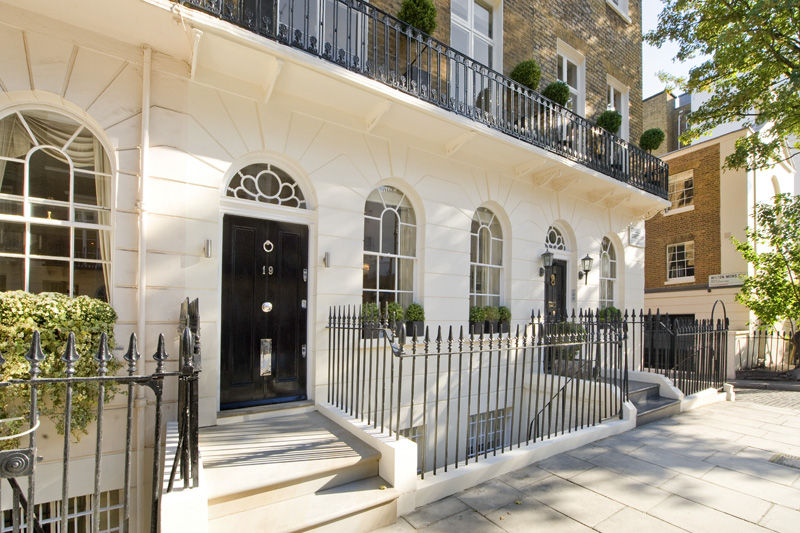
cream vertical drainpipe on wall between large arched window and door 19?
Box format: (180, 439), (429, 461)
(136, 45), (155, 524)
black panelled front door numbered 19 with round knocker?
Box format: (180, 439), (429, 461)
(220, 215), (308, 409)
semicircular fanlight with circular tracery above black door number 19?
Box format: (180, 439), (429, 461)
(225, 163), (308, 209)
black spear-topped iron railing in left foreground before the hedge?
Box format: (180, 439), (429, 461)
(0, 328), (200, 533)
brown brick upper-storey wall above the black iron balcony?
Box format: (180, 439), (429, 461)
(373, 0), (642, 142)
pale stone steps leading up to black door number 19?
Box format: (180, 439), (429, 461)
(200, 412), (397, 533)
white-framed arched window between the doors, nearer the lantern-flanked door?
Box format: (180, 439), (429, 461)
(469, 207), (503, 306)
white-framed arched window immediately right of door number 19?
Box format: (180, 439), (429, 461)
(363, 186), (417, 307)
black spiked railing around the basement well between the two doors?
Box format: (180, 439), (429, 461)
(327, 307), (627, 477)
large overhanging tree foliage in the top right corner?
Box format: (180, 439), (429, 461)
(645, 0), (800, 168)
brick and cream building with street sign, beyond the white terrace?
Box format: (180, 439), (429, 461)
(644, 92), (798, 329)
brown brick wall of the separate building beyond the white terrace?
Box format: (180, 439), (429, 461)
(644, 143), (720, 289)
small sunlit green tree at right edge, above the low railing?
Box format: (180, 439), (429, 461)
(733, 194), (800, 331)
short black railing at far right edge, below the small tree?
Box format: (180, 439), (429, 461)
(735, 329), (800, 377)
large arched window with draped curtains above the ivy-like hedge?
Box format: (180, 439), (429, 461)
(0, 110), (112, 300)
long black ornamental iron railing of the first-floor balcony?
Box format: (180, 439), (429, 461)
(178, 0), (668, 198)
